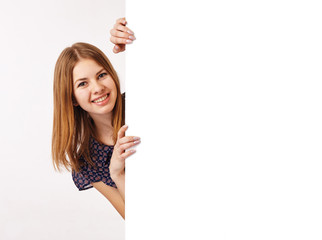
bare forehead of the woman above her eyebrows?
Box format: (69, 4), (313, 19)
(73, 59), (103, 81)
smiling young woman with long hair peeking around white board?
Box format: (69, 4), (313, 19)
(52, 18), (140, 218)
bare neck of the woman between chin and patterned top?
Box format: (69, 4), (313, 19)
(91, 113), (114, 145)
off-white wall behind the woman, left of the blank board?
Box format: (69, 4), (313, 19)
(0, 0), (125, 240)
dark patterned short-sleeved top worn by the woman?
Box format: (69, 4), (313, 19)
(72, 144), (116, 191)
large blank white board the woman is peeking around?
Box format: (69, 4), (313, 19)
(126, 0), (322, 240)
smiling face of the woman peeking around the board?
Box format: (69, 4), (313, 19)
(73, 59), (117, 119)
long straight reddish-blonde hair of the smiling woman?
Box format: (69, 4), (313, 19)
(52, 43), (124, 171)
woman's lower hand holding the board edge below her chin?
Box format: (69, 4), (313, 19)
(109, 125), (141, 179)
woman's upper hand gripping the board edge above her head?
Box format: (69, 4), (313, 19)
(110, 18), (136, 53)
